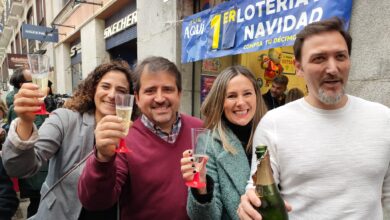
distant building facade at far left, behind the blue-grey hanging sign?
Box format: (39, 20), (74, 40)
(0, 0), (48, 96)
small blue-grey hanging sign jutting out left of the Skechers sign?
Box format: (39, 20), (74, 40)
(22, 24), (58, 42)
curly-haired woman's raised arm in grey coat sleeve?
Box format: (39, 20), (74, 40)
(3, 83), (63, 177)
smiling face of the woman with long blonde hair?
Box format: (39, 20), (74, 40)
(223, 74), (256, 126)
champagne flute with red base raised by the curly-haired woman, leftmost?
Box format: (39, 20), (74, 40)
(28, 54), (49, 115)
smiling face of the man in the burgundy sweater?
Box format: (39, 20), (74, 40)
(135, 68), (181, 133)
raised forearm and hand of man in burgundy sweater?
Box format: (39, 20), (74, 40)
(78, 115), (129, 210)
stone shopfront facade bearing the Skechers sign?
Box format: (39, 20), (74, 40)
(50, 0), (137, 94)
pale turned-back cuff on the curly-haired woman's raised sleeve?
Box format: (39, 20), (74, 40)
(8, 118), (39, 150)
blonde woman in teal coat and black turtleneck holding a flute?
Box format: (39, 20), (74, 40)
(181, 66), (266, 220)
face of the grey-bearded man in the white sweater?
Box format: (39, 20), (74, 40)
(296, 31), (351, 109)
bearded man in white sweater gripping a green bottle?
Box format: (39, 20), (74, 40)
(238, 18), (390, 220)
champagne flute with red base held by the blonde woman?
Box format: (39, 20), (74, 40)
(186, 128), (211, 188)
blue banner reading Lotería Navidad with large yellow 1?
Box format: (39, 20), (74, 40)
(181, 0), (352, 63)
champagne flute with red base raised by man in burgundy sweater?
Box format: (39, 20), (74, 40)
(115, 93), (134, 153)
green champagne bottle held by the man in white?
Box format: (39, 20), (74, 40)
(252, 146), (288, 220)
